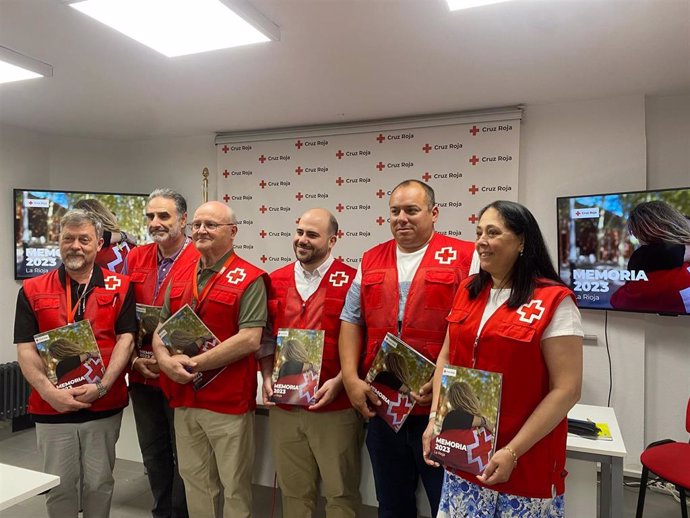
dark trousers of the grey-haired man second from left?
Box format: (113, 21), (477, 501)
(129, 383), (188, 518)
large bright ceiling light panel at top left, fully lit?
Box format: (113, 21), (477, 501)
(70, 0), (277, 57)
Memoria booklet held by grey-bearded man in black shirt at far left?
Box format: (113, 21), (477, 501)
(34, 320), (105, 388)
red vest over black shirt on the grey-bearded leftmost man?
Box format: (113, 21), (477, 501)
(24, 266), (129, 415)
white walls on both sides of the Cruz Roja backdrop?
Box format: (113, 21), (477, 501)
(0, 92), (690, 476)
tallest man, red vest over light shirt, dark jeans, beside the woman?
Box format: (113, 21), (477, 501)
(340, 180), (474, 518)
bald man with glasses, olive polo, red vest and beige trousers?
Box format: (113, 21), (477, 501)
(153, 201), (268, 518)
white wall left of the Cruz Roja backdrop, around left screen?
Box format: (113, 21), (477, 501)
(0, 125), (216, 363)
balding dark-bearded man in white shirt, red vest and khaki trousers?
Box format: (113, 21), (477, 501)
(262, 209), (363, 518)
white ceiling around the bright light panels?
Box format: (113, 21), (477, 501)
(0, 0), (690, 139)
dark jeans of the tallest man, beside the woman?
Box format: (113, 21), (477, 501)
(366, 415), (443, 518)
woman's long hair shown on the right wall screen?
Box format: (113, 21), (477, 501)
(628, 200), (690, 245)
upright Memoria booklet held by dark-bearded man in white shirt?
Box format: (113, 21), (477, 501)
(271, 328), (324, 406)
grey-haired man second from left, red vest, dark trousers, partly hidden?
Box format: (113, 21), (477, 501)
(121, 189), (199, 518)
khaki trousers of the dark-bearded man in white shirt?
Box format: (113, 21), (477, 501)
(269, 407), (364, 518)
